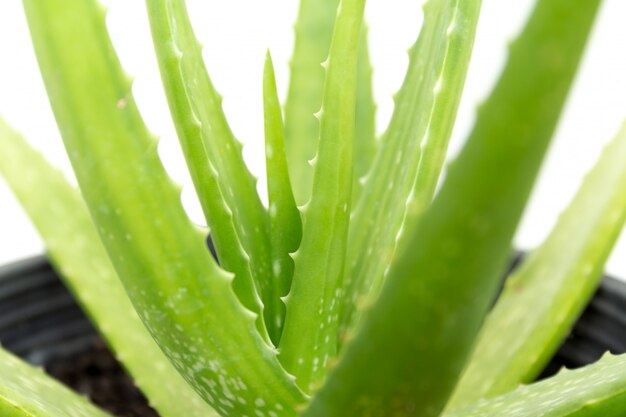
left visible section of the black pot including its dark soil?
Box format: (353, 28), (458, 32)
(0, 256), (158, 417)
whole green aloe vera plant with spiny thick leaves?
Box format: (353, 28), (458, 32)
(0, 0), (626, 417)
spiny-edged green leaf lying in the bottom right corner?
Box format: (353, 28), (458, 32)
(444, 355), (626, 417)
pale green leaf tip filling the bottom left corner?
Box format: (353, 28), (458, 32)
(0, 348), (111, 417)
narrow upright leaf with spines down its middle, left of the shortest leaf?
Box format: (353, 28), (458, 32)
(146, 0), (276, 340)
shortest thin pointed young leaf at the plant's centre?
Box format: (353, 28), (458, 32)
(263, 51), (302, 338)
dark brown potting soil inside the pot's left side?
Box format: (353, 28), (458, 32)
(46, 340), (159, 417)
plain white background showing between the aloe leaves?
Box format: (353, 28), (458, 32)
(0, 0), (626, 278)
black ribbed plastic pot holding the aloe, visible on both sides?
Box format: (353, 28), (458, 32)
(0, 256), (626, 416)
